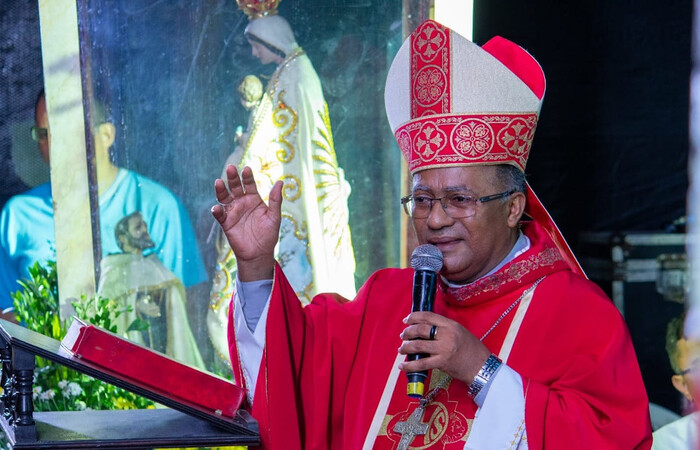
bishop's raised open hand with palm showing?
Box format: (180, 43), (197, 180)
(211, 165), (282, 281)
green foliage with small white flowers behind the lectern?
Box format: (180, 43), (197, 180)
(12, 261), (154, 411)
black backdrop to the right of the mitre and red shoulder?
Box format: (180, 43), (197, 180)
(474, 0), (693, 412)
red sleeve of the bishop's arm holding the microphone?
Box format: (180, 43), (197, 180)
(509, 276), (651, 450)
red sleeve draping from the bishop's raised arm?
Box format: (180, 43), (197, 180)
(229, 265), (380, 448)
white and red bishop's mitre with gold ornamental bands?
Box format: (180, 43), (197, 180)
(385, 20), (545, 173)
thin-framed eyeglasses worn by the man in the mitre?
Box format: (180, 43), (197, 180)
(401, 190), (517, 219)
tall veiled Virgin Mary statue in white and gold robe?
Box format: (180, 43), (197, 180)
(207, 2), (355, 368)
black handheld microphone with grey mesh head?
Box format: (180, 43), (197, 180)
(406, 244), (442, 397)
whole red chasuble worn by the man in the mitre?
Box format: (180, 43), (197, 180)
(229, 224), (651, 450)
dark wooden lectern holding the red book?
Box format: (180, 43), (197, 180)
(0, 319), (260, 449)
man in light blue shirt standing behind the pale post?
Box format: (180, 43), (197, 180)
(0, 91), (207, 317)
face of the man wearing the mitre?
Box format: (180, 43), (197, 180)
(412, 166), (522, 283)
